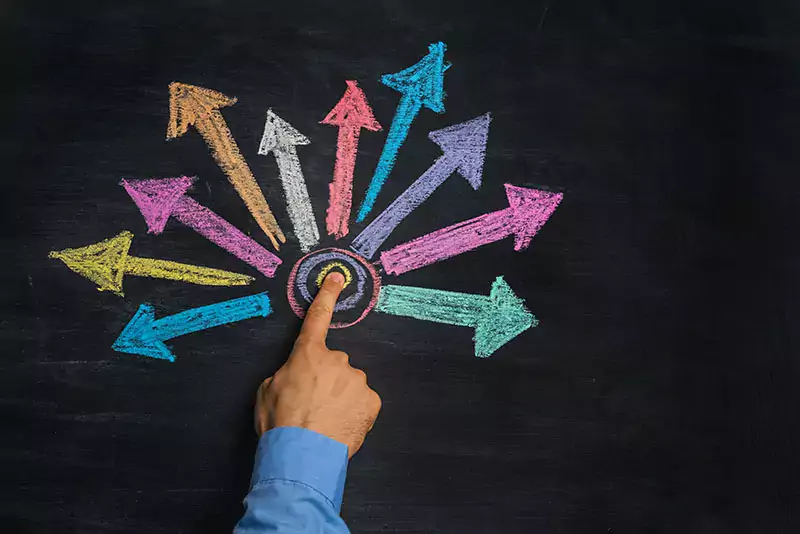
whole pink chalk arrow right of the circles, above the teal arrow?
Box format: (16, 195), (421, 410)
(381, 184), (564, 274)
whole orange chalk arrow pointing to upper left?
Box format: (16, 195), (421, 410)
(167, 82), (286, 250)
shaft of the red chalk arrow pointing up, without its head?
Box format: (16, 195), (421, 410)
(325, 126), (361, 239)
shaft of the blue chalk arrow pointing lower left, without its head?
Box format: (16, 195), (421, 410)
(153, 293), (272, 341)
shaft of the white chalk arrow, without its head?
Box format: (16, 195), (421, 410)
(274, 146), (319, 252)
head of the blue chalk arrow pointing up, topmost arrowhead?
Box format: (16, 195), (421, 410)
(381, 42), (450, 113)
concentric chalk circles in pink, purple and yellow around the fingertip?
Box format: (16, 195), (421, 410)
(286, 248), (381, 328)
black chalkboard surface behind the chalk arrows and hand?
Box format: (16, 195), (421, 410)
(0, 0), (800, 534)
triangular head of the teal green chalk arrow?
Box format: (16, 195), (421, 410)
(475, 276), (539, 358)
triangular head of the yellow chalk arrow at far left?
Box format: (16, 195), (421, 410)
(50, 232), (133, 296)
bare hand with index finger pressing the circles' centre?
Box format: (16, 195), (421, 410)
(255, 271), (381, 458)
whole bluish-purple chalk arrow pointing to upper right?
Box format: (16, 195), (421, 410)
(350, 113), (492, 258)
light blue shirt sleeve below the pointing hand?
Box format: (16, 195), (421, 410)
(233, 427), (350, 534)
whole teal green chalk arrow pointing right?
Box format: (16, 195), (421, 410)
(375, 276), (539, 358)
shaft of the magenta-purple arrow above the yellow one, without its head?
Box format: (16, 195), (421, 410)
(172, 196), (281, 278)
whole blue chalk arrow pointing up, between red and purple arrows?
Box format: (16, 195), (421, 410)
(356, 42), (449, 222)
